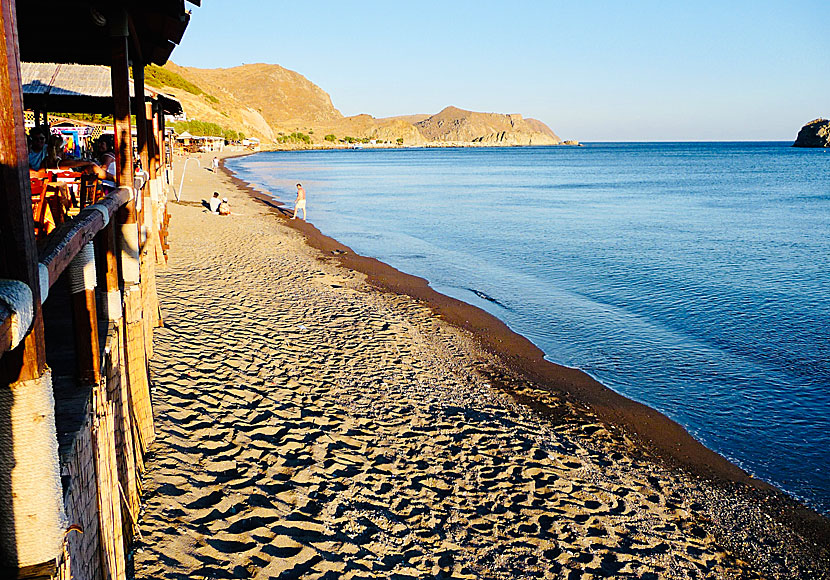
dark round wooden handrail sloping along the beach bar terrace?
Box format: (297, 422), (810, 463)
(0, 187), (132, 353)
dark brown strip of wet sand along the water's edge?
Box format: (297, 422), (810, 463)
(220, 152), (830, 524)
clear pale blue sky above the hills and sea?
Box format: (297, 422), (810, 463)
(172, 0), (830, 141)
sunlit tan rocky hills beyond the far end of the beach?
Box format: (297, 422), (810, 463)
(158, 62), (562, 146)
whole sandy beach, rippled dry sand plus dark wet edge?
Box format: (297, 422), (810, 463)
(133, 156), (830, 578)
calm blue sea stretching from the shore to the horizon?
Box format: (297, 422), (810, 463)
(227, 143), (830, 513)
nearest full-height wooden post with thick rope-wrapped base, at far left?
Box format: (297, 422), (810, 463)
(0, 0), (64, 578)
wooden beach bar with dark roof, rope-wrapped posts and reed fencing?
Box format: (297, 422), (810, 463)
(0, 0), (200, 580)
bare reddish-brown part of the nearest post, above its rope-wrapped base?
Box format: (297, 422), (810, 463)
(0, 0), (46, 386)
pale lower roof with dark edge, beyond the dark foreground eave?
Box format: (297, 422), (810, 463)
(20, 62), (182, 115)
